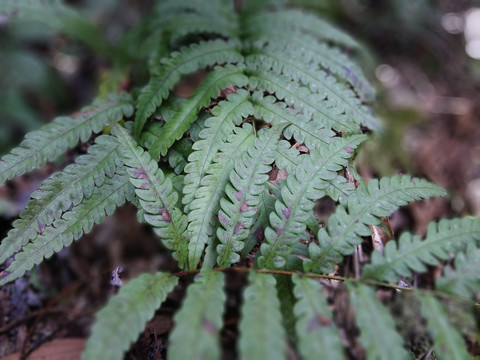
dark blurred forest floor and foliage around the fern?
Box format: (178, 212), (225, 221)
(0, 0), (480, 357)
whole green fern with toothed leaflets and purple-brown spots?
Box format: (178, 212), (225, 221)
(0, 0), (480, 359)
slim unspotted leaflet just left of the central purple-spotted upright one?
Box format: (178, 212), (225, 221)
(188, 123), (254, 269)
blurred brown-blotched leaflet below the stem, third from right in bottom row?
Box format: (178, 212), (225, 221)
(292, 274), (344, 360)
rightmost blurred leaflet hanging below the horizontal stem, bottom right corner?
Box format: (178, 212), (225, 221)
(416, 293), (472, 360)
